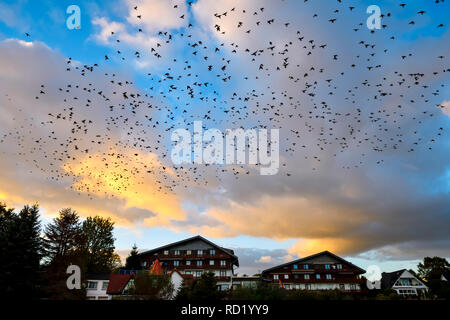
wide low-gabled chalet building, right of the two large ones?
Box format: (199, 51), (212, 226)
(261, 251), (365, 292)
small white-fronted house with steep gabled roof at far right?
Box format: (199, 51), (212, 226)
(381, 269), (428, 296)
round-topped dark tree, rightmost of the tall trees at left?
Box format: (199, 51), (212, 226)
(82, 216), (117, 273)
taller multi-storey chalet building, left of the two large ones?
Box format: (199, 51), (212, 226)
(139, 236), (239, 290)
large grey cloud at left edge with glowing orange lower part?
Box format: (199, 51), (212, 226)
(0, 40), (185, 228)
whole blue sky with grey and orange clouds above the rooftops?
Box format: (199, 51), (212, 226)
(0, 0), (450, 274)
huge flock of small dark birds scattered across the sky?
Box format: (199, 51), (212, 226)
(0, 0), (450, 197)
